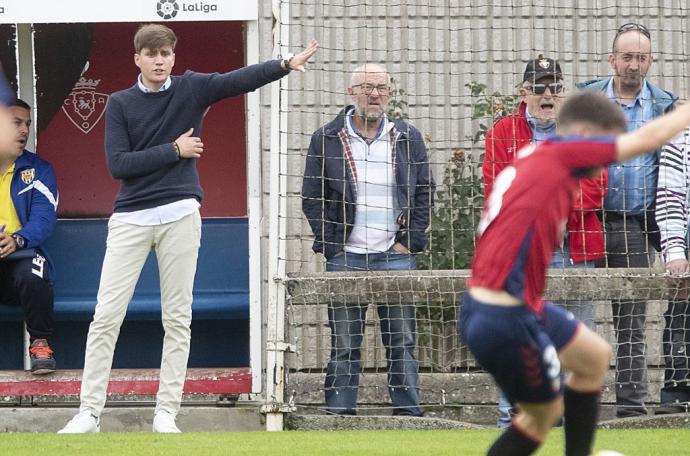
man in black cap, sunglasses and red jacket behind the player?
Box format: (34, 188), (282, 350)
(482, 55), (607, 428)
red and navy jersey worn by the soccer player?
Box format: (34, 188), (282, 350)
(468, 137), (616, 313)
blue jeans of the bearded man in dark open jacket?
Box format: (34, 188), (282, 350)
(324, 250), (424, 416)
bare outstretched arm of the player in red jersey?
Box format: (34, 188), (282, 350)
(616, 103), (690, 161)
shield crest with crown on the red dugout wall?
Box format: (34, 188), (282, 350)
(62, 77), (108, 134)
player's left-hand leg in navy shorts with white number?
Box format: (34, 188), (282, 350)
(460, 293), (563, 456)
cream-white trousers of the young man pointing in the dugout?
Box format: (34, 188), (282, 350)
(80, 211), (201, 416)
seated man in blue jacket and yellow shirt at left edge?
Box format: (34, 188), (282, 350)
(0, 100), (58, 374)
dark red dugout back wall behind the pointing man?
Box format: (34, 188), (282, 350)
(36, 22), (247, 218)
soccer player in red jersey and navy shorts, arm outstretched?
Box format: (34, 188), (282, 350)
(460, 92), (690, 456)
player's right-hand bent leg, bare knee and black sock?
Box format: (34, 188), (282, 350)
(542, 303), (611, 456)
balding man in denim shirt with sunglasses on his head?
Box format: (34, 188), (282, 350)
(578, 23), (677, 418)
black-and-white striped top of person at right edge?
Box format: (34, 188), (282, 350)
(656, 129), (690, 262)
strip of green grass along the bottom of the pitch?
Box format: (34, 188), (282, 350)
(0, 429), (690, 456)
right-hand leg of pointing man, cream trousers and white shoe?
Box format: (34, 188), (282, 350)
(154, 211), (201, 432)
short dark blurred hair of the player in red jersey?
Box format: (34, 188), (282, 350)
(556, 90), (626, 131)
